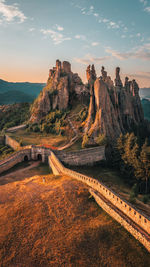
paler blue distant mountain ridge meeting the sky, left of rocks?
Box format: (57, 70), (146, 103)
(0, 79), (46, 98)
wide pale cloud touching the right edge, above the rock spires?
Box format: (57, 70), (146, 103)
(105, 43), (150, 60)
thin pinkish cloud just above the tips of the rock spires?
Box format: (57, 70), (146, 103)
(74, 54), (110, 65)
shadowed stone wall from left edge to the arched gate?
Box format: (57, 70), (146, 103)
(0, 149), (31, 176)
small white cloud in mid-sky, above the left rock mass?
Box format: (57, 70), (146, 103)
(41, 29), (71, 45)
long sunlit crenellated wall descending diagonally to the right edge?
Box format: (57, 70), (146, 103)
(50, 152), (150, 240)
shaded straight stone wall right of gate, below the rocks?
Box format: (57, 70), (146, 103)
(55, 146), (106, 166)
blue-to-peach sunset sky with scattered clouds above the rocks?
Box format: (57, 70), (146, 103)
(0, 0), (150, 87)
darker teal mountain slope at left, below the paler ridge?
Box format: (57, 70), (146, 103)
(0, 91), (34, 105)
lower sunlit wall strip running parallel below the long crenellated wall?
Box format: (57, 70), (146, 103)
(89, 189), (150, 252)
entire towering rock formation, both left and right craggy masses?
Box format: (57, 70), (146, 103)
(30, 60), (144, 144)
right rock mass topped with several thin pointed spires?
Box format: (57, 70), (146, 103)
(84, 66), (144, 143)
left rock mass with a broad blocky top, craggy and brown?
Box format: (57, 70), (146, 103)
(30, 60), (87, 123)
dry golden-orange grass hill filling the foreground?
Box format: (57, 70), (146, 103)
(0, 166), (150, 267)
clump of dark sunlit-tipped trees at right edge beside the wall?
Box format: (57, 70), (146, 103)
(114, 133), (150, 194)
